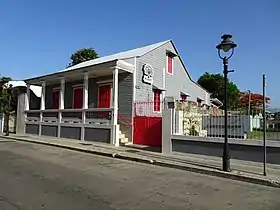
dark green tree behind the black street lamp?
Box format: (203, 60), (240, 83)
(197, 72), (240, 109)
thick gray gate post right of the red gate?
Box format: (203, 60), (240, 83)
(161, 109), (175, 154)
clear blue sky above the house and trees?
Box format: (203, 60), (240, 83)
(0, 0), (280, 107)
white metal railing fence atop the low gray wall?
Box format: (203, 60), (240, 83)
(172, 103), (280, 140)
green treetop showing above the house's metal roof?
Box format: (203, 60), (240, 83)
(67, 48), (99, 67)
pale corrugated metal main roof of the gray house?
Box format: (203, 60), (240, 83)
(63, 40), (170, 71)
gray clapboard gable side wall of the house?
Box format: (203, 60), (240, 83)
(136, 41), (210, 104)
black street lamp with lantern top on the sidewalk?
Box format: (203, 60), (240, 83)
(216, 34), (237, 172)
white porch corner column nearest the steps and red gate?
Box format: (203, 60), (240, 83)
(112, 68), (119, 146)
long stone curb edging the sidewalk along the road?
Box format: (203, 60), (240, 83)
(5, 136), (280, 188)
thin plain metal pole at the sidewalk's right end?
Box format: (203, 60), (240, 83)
(263, 74), (266, 176)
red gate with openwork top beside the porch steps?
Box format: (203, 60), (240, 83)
(133, 102), (162, 146)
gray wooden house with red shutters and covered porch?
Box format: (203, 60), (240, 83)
(20, 40), (211, 146)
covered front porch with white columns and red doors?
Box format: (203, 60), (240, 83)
(24, 60), (134, 146)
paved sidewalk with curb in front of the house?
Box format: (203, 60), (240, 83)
(2, 134), (280, 188)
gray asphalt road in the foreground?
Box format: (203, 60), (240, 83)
(0, 139), (280, 210)
